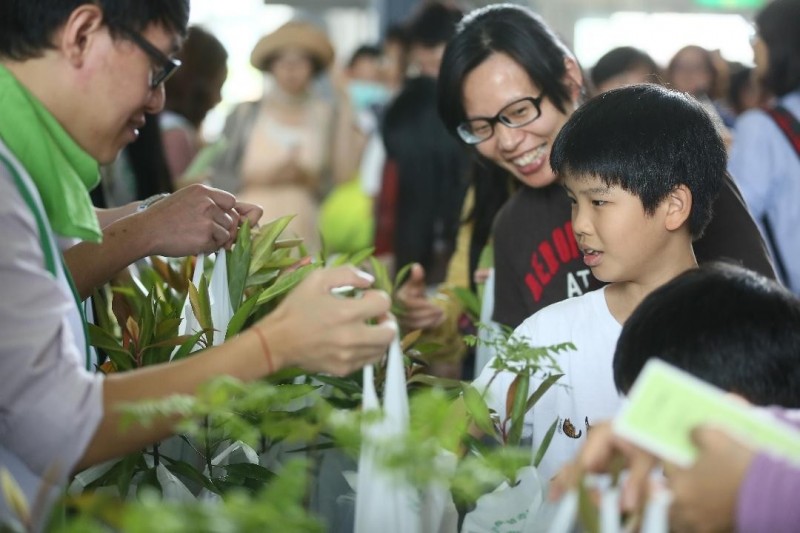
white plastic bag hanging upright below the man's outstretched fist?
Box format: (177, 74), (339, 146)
(354, 339), (421, 533)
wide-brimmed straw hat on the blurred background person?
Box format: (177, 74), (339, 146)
(250, 21), (333, 70)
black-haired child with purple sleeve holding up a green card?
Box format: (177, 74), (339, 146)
(551, 265), (800, 532)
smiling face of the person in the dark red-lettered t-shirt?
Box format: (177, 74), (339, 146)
(463, 53), (580, 188)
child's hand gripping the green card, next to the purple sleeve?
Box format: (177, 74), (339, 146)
(668, 428), (755, 532)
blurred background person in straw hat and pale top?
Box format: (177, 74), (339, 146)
(212, 21), (360, 252)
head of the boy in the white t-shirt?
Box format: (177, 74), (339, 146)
(550, 85), (726, 281)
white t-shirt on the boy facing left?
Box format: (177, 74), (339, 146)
(473, 288), (622, 482)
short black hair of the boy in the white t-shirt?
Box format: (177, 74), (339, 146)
(550, 84), (727, 239)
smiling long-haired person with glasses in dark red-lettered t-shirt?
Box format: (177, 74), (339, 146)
(397, 4), (775, 378)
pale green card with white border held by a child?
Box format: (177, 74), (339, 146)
(614, 359), (800, 467)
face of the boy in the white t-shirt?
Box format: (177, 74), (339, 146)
(562, 175), (669, 283)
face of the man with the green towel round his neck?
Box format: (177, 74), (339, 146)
(71, 20), (179, 163)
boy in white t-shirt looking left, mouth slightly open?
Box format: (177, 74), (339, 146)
(474, 85), (726, 480)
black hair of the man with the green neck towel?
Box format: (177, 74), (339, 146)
(0, 0), (189, 61)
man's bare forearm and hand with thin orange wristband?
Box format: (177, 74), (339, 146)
(78, 267), (396, 469)
